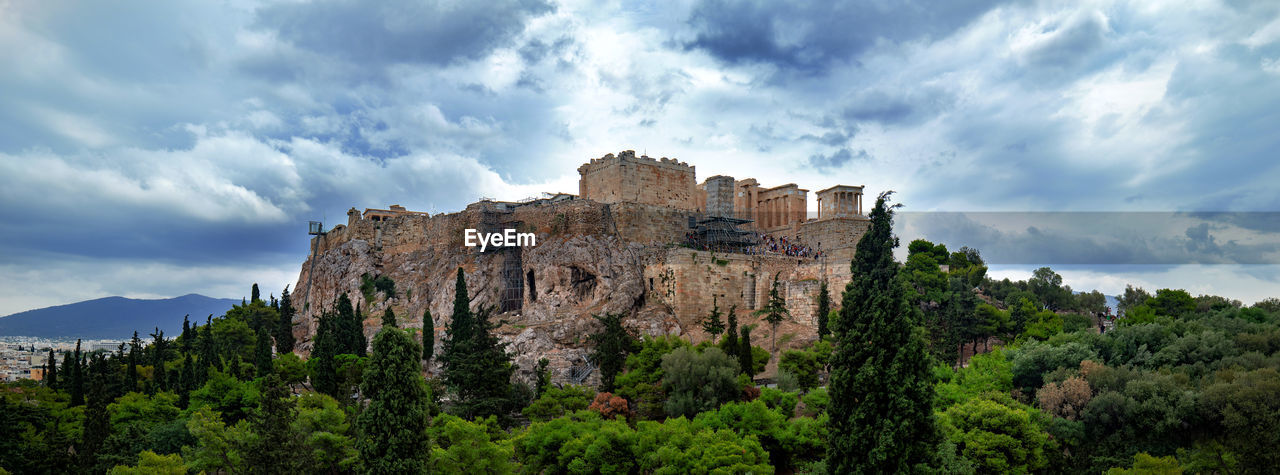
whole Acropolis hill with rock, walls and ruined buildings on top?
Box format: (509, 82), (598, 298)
(293, 150), (869, 382)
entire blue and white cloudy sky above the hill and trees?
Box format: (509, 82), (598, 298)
(0, 0), (1280, 315)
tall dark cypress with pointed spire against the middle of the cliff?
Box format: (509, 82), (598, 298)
(440, 268), (515, 419)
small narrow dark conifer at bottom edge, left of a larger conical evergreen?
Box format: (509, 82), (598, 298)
(246, 373), (305, 474)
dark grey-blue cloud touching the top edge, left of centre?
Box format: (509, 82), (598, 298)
(257, 0), (554, 64)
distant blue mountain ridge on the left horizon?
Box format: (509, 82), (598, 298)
(0, 293), (241, 339)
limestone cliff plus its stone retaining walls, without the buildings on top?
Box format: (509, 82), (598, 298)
(292, 200), (849, 383)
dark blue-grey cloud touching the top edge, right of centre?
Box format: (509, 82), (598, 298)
(684, 0), (997, 73)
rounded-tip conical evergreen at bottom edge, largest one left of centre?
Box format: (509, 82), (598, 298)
(356, 326), (430, 474)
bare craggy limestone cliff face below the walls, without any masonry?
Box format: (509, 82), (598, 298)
(294, 234), (681, 389)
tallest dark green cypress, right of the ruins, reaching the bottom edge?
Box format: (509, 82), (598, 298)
(827, 192), (938, 474)
